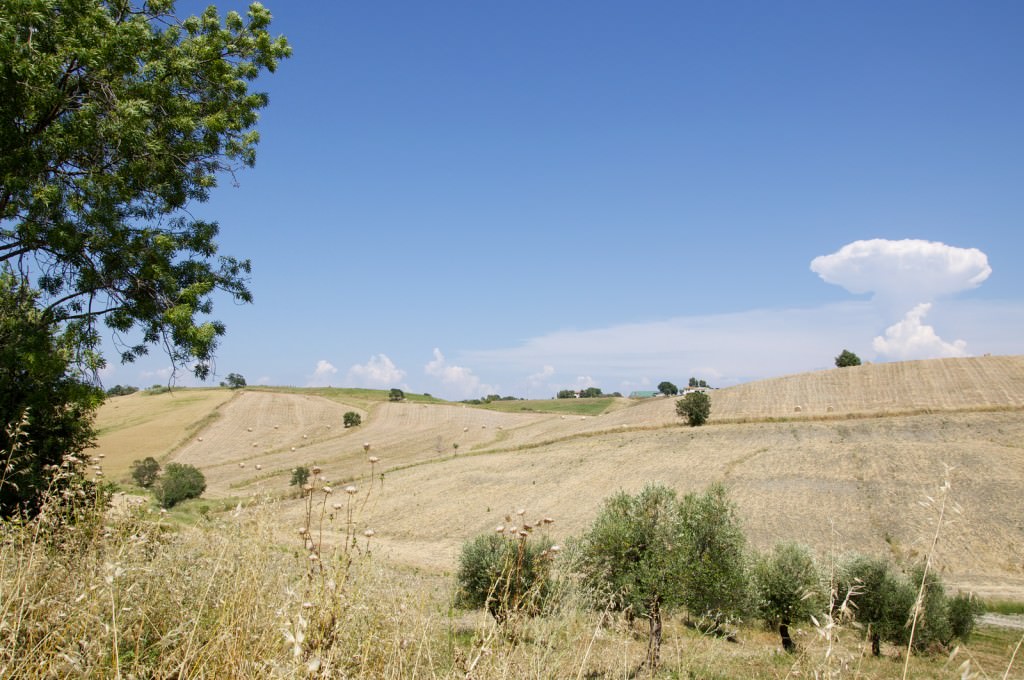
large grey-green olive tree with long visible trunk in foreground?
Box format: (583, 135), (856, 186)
(581, 484), (684, 669)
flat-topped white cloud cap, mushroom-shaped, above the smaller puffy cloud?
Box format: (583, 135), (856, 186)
(811, 239), (992, 313)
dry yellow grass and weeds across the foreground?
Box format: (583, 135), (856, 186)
(0, 481), (1021, 679)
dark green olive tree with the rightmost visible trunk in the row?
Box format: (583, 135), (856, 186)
(838, 555), (914, 656)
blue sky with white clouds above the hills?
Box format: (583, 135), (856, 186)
(104, 0), (1024, 398)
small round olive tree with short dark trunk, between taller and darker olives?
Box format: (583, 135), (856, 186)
(753, 543), (823, 651)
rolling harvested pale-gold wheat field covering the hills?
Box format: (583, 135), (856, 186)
(100, 356), (1024, 600)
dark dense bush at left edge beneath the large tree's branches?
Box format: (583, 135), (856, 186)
(0, 270), (103, 517)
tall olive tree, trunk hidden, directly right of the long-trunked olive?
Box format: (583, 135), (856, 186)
(680, 483), (752, 628)
